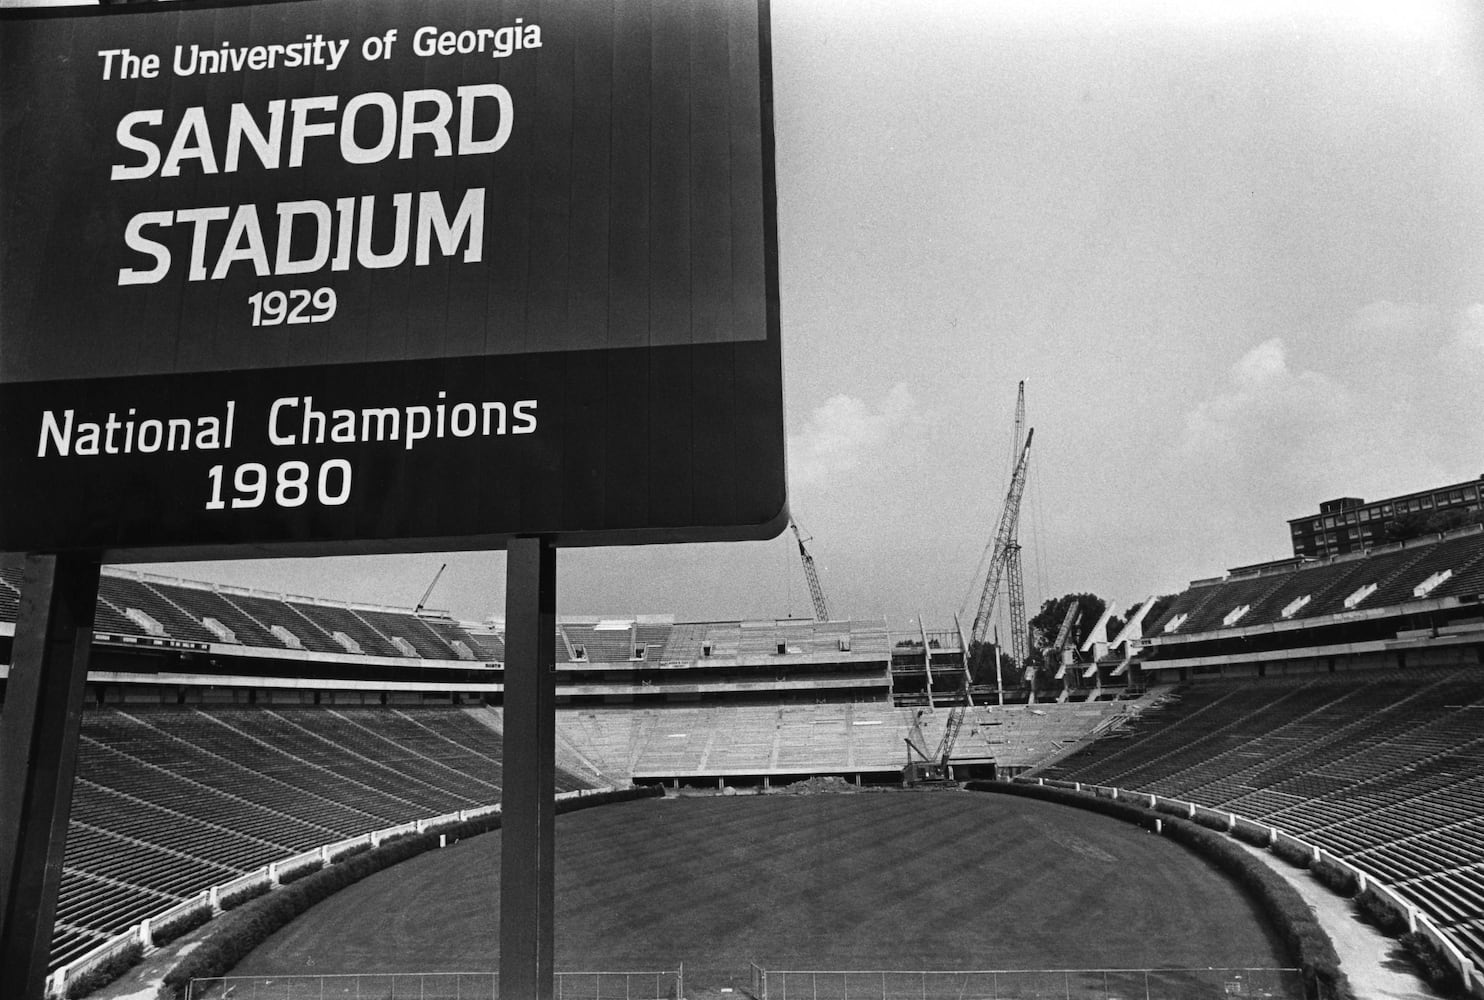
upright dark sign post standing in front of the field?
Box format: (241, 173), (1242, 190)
(500, 537), (557, 1000)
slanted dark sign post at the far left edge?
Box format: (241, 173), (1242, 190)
(0, 555), (99, 999)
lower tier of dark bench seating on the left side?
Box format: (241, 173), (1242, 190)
(43, 700), (600, 967)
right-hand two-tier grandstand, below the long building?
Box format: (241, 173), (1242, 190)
(1030, 528), (1484, 967)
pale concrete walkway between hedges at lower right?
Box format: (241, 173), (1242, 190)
(1232, 837), (1442, 1000)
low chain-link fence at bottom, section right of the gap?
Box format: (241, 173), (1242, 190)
(747, 963), (1304, 1000)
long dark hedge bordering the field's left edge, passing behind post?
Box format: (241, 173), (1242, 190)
(163, 786), (665, 997)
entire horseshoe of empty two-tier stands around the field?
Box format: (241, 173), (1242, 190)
(11, 530), (1484, 991)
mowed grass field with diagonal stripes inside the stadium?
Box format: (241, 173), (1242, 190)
(236, 792), (1288, 987)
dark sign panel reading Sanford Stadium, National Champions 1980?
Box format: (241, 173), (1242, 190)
(0, 0), (787, 559)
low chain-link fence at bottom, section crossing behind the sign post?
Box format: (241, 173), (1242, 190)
(186, 967), (686, 1000)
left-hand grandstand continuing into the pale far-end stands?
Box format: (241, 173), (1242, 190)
(0, 565), (1138, 967)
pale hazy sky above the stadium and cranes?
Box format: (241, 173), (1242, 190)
(17, 0), (1484, 629)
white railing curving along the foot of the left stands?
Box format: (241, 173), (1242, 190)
(46, 789), (617, 999)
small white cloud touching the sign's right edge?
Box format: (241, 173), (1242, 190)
(788, 383), (923, 485)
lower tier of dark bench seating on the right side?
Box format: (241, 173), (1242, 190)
(1039, 670), (1484, 963)
